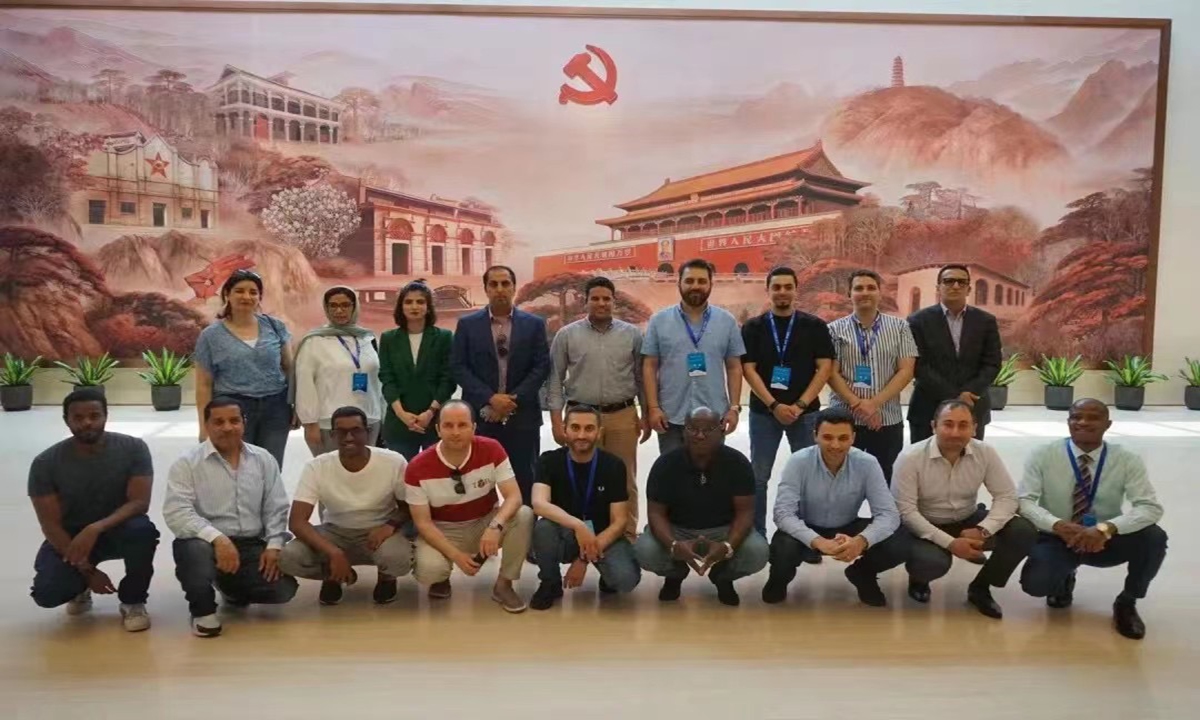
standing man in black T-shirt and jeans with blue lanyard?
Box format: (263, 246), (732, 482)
(742, 268), (836, 538)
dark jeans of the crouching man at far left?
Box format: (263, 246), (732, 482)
(30, 515), (158, 607)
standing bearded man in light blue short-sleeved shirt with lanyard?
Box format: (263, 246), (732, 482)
(642, 258), (746, 455)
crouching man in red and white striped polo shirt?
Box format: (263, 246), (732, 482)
(404, 400), (534, 612)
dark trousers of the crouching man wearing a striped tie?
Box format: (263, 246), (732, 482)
(1021, 524), (1166, 600)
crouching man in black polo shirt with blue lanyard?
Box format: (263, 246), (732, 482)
(529, 406), (642, 610)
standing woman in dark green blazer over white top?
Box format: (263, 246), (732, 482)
(379, 280), (457, 460)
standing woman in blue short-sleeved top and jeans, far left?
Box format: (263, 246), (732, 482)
(193, 270), (296, 468)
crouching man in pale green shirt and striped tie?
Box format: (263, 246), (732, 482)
(1020, 398), (1166, 640)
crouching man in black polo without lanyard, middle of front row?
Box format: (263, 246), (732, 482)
(634, 407), (768, 605)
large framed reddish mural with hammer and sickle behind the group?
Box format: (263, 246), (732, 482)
(0, 0), (1171, 366)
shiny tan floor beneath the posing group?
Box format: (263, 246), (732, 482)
(0, 408), (1200, 720)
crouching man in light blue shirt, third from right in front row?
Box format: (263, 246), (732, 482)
(762, 409), (911, 607)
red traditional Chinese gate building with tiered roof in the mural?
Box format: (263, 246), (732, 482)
(534, 143), (868, 277)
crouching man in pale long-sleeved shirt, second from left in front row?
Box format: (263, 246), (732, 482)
(162, 397), (296, 637)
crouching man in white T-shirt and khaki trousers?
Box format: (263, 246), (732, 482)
(280, 407), (413, 605)
